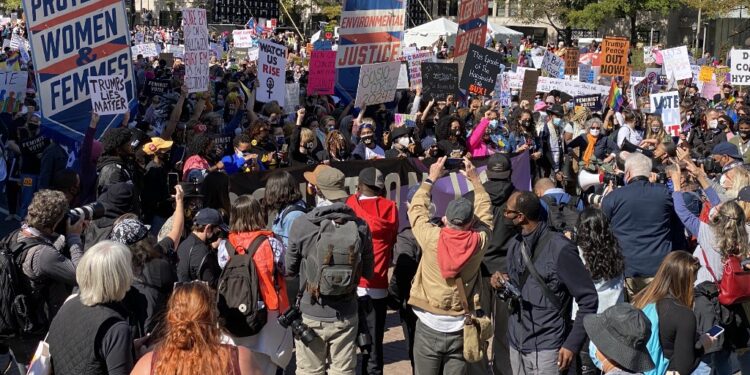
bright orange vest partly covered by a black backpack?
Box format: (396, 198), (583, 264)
(229, 230), (289, 313)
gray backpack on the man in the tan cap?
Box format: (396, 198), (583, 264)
(305, 219), (362, 299)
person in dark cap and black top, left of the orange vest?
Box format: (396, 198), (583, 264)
(177, 208), (228, 288)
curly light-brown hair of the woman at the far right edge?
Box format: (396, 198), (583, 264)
(710, 201), (750, 259)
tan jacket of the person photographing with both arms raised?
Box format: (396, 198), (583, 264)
(408, 183), (492, 316)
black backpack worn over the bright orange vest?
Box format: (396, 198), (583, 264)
(216, 236), (268, 337)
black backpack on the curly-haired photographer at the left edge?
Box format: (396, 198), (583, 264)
(0, 229), (46, 337)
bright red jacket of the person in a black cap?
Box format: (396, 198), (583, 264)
(346, 194), (398, 289)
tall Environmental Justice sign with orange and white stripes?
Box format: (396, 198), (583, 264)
(336, 0), (406, 101)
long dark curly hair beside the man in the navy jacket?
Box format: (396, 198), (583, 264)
(576, 207), (625, 281)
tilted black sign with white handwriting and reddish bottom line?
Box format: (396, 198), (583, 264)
(460, 44), (501, 96)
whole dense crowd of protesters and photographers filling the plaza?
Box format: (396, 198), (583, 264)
(0, 13), (750, 375)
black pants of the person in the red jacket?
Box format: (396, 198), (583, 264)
(358, 296), (388, 375)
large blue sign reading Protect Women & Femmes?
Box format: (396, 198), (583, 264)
(22, 0), (136, 141)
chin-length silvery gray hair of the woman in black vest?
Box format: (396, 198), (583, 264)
(76, 241), (133, 306)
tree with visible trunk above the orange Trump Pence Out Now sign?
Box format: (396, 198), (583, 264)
(568, 0), (680, 45)
